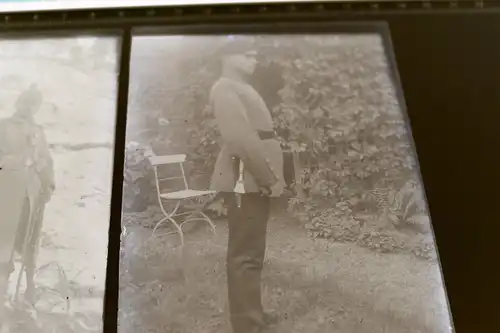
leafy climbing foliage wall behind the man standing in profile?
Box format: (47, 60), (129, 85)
(127, 35), (432, 253)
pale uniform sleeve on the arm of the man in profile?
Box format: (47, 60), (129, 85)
(211, 86), (278, 187)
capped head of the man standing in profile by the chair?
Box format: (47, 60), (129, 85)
(221, 37), (257, 76)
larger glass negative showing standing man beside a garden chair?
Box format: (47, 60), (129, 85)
(119, 30), (451, 333)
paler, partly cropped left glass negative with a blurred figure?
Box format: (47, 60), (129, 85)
(0, 37), (117, 333)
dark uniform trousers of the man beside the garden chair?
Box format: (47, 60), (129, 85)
(224, 193), (270, 333)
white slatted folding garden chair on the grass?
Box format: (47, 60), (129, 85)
(148, 151), (216, 245)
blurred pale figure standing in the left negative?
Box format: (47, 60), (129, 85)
(0, 85), (55, 314)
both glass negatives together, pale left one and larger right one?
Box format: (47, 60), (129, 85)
(0, 24), (452, 333)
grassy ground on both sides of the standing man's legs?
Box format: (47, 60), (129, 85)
(120, 202), (451, 333)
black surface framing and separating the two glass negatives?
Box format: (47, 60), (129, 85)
(0, 0), (500, 333)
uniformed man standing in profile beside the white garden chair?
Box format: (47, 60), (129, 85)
(210, 37), (284, 333)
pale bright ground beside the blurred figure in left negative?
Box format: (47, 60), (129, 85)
(5, 148), (112, 332)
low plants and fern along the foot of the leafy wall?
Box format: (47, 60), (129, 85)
(298, 182), (436, 259)
